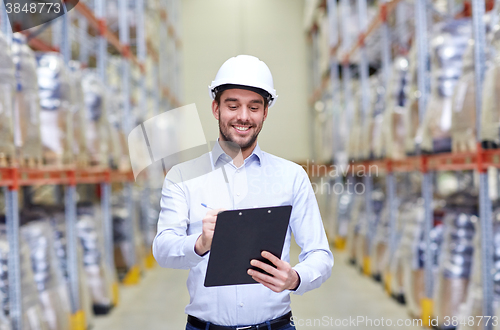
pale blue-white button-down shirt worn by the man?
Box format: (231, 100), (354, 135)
(153, 143), (333, 326)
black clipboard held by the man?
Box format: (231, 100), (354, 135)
(205, 205), (292, 287)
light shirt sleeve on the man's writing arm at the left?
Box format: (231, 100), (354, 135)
(153, 169), (207, 269)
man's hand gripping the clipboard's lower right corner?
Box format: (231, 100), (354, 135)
(247, 251), (300, 292)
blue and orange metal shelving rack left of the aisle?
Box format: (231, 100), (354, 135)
(0, 0), (182, 330)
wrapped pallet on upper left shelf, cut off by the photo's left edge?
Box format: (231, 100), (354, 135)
(0, 33), (16, 167)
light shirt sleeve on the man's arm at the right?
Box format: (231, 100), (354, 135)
(290, 168), (333, 295)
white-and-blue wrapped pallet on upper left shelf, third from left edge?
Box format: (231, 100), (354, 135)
(36, 52), (73, 165)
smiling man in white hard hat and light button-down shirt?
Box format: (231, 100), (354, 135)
(153, 55), (333, 330)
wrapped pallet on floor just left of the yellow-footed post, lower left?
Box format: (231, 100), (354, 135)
(21, 217), (71, 330)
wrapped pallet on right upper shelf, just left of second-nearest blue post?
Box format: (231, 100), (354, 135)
(382, 57), (409, 159)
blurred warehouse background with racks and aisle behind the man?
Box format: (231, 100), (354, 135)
(0, 0), (500, 330)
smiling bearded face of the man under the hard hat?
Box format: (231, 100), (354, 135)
(212, 89), (268, 158)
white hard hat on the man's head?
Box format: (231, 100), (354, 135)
(208, 55), (278, 107)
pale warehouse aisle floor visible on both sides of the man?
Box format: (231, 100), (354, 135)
(93, 245), (422, 330)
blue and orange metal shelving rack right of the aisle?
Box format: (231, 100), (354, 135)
(309, 0), (500, 330)
